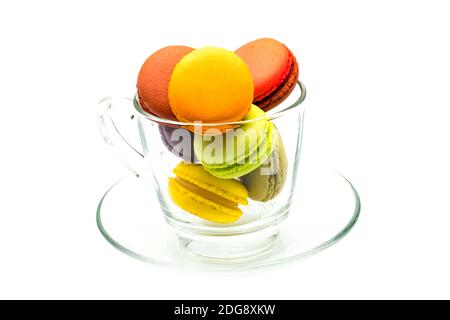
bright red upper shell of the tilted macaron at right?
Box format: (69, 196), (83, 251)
(235, 38), (293, 102)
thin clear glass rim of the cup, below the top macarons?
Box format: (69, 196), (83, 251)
(133, 81), (306, 127)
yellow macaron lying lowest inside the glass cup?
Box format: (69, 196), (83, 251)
(169, 162), (248, 224)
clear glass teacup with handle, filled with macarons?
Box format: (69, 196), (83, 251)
(99, 82), (306, 263)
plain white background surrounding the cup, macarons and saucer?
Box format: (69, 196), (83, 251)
(0, 0), (450, 299)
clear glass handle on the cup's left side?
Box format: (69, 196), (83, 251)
(97, 97), (144, 177)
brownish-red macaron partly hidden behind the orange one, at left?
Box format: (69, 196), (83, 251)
(137, 46), (194, 120)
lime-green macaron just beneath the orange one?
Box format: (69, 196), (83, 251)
(194, 105), (275, 179)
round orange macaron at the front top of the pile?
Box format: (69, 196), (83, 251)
(169, 47), (254, 130)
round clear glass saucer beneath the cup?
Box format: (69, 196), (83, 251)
(97, 168), (361, 270)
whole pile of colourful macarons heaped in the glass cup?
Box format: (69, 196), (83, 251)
(137, 38), (299, 223)
